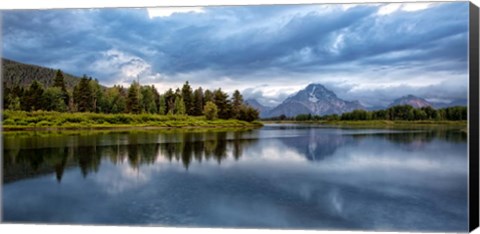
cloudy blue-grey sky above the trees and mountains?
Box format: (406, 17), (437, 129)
(1, 2), (468, 106)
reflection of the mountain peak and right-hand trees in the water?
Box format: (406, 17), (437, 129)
(273, 126), (467, 161)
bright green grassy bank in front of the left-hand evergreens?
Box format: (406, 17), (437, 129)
(2, 110), (262, 131)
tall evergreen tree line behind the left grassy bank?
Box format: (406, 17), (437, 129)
(3, 70), (259, 121)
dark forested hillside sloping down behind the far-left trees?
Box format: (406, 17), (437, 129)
(2, 58), (80, 89)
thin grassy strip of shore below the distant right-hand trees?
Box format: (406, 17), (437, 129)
(262, 120), (467, 128)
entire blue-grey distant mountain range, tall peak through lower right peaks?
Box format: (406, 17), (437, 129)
(246, 84), (467, 118)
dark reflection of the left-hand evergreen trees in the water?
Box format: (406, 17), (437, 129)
(3, 131), (257, 183)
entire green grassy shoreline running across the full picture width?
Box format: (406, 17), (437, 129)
(2, 111), (468, 132)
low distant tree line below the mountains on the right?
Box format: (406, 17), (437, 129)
(269, 105), (467, 121)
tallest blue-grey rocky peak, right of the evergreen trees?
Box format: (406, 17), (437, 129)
(268, 84), (365, 117)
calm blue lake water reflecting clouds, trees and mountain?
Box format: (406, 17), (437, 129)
(2, 125), (467, 231)
